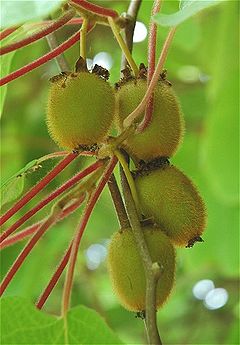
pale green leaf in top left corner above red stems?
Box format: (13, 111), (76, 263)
(1, 0), (63, 28)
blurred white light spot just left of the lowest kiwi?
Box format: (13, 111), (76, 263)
(85, 243), (107, 270)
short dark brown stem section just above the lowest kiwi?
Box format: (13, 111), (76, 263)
(108, 174), (130, 229)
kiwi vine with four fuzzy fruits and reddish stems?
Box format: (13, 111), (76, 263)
(0, 0), (206, 344)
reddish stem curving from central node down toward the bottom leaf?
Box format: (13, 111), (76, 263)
(62, 156), (117, 315)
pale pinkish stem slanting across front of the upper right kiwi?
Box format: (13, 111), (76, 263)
(123, 28), (176, 128)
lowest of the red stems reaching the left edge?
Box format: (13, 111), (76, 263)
(0, 214), (57, 296)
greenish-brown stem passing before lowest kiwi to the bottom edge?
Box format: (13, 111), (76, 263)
(122, 174), (162, 345)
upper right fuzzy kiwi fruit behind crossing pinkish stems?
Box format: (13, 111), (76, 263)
(116, 78), (184, 161)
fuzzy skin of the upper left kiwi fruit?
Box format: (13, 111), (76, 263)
(47, 72), (115, 149)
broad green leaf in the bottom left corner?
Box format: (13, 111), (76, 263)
(1, 297), (123, 345)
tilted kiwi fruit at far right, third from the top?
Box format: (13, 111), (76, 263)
(135, 165), (206, 247)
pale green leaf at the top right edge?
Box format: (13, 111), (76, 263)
(153, 0), (223, 26)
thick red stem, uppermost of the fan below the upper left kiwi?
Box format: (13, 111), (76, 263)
(0, 152), (78, 227)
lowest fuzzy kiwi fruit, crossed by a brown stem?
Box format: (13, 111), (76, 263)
(108, 226), (175, 312)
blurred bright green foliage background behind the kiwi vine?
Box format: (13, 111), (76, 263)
(1, 1), (239, 344)
